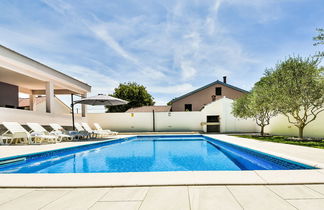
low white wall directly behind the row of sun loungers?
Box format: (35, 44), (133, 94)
(0, 107), (86, 126)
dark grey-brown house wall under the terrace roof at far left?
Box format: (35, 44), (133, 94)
(0, 82), (18, 107)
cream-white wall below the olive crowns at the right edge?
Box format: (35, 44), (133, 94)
(265, 112), (324, 137)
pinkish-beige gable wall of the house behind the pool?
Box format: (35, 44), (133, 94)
(172, 84), (244, 112)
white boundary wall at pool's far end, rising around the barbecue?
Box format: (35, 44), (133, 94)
(87, 98), (257, 133)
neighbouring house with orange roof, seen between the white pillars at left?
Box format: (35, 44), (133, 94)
(19, 96), (71, 114)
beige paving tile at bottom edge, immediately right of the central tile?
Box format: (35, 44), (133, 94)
(189, 186), (242, 210)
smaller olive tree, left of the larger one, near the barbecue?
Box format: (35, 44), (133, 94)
(232, 77), (277, 136)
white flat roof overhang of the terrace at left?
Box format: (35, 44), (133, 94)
(0, 45), (91, 95)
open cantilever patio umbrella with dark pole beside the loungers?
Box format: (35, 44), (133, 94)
(72, 94), (128, 130)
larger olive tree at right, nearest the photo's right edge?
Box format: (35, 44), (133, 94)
(267, 56), (324, 138)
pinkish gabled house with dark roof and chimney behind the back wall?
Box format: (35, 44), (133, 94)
(171, 77), (248, 112)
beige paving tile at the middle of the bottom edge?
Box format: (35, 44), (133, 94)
(140, 187), (190, 210)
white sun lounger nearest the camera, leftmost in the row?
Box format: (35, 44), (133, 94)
(2, 122), (47, 144)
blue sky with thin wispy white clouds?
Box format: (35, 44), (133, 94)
(0, 0), (324, 109)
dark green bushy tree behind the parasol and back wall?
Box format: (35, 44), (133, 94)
(106, 82), (154, 112)
